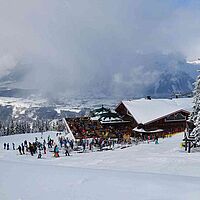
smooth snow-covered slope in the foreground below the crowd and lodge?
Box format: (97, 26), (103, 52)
(0, 132), (200, 200)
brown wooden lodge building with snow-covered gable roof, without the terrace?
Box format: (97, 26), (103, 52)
(115, 98), (192, 136)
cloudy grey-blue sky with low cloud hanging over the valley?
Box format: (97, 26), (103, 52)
(0, 0), (200, 97)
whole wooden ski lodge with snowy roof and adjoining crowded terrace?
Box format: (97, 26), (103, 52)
(65, 98), (192, 139)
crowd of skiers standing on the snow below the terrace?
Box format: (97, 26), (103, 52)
(3, 130), (134, 158)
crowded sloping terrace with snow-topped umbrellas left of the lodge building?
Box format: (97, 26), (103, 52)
(65, 106), (132, 139)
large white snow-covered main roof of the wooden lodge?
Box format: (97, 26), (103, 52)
(119, 98), (192, 124)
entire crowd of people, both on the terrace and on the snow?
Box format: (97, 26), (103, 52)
(3, 123), (162, 158)
